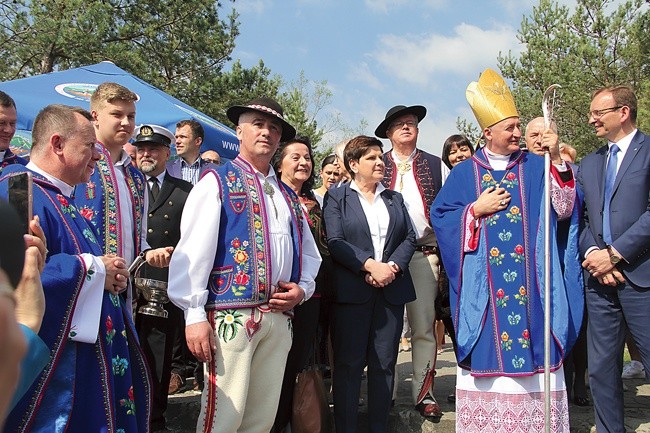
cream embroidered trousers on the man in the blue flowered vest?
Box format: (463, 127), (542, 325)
(196, 308), (291, 433)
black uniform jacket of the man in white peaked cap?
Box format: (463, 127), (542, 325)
(140, 173), (192, 281)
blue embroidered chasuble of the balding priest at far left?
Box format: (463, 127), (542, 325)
(0, 165), (151, 433)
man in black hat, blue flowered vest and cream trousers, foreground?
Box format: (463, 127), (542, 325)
(169, 98), (321, 433)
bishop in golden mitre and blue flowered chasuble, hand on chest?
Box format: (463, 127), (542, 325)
(431, 69), (584, 432)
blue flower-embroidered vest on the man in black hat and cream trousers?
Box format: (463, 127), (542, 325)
(205, 157), (303, 310)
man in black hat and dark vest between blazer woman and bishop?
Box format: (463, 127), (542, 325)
(375, 105), (449, 418)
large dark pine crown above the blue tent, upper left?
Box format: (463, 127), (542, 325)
(0, 0), (239, 90)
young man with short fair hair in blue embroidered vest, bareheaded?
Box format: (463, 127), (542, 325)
(75, 82), (173, 300)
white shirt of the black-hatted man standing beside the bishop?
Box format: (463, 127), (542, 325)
(392, 149), (449, 245)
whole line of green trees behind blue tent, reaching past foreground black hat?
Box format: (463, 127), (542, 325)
(0, 0), (360, 164)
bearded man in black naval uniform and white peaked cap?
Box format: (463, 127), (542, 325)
(134, 125), (192, 431)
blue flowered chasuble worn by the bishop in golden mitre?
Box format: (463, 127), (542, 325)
(431, 151), (584, 377)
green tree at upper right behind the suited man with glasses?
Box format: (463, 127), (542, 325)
(498, 0), (650, 156)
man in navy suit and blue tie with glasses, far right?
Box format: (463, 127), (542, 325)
(578, 86), (650, 433)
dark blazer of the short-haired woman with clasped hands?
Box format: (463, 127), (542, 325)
(323, 183), (415, 305)
